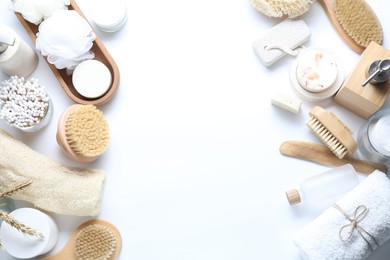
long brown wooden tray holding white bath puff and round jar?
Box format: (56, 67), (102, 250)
(15, 0), (119, 106)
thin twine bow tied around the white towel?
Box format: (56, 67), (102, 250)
(333, 204), (378, 251)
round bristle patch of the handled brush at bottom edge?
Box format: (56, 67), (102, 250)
(75, 224), (116, 260)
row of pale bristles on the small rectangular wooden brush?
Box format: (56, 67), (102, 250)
(306, 116), (348, 159)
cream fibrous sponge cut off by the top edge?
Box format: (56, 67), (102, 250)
(251, 0), (313, 18)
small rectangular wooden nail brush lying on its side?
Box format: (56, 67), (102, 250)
(306, 106), (357, 159)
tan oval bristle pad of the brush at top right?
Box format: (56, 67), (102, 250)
(334, 0), (383, 48)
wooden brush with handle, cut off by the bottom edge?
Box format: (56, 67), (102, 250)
(43, 219), (122, 260)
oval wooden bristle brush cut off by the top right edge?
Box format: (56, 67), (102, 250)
(320, 0), (383, 53)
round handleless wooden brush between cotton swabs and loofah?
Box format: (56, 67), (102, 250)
(56, 104), (109, 162)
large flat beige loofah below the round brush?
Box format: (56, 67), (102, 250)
(0, 130), (105, 216)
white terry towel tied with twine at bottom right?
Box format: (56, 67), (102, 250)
(294, 171), (390, 260)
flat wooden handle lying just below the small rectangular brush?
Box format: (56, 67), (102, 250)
(279, 140), (387, 174)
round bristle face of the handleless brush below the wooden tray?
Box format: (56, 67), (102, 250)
(65, 105), (109, 157)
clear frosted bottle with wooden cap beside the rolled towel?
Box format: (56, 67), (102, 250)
(286, 164), (359, 205)
